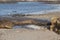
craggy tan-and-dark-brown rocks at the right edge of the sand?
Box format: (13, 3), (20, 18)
(50, 17), (60, 34)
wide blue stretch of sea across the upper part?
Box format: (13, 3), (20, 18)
(0, 2), (60, 15)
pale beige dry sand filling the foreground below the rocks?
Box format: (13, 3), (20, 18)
(0, 29), (60, 40)
